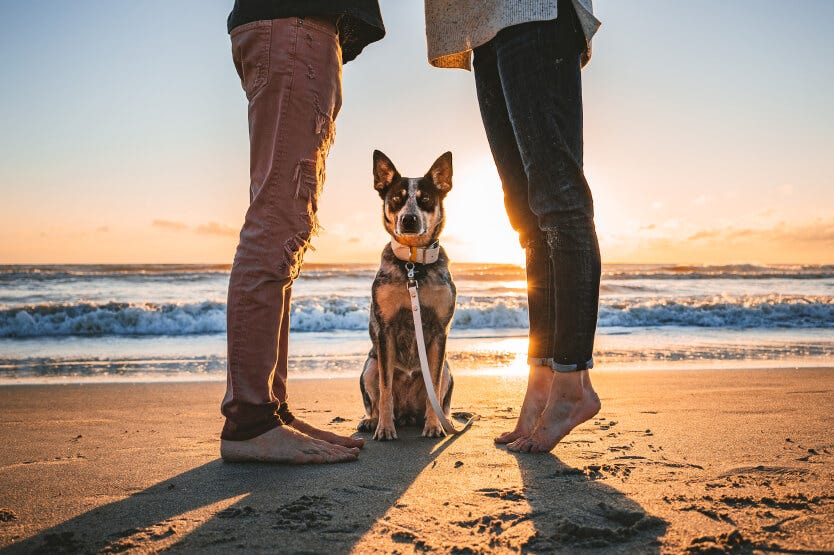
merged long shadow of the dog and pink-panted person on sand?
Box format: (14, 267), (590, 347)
(8, 427), (459, 553)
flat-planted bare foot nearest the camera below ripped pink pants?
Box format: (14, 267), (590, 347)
(220, 426), (359, 464)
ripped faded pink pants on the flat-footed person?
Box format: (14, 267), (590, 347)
(221, 18), (342, 441)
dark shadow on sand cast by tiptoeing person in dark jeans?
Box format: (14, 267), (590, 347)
(515, 453), (667, 553)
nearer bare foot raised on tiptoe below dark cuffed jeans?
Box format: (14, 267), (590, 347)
(507, 370), (601, 453)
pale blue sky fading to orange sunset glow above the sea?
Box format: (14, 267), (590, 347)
(0, 0), (834, 264)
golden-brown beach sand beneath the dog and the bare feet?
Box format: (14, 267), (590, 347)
(0, 369), (834, 554)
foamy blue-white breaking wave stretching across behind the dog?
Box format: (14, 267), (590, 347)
(0, 295), (834, 338)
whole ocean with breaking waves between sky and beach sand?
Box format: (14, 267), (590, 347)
(0, 263), (834, 384)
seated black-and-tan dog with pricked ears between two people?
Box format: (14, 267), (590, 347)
(359, 150), (457, 441)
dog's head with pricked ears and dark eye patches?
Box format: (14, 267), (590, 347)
(374, 150), (452, 247)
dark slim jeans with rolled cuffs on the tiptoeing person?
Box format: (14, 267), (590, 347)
(473, 0), (601, 372)
